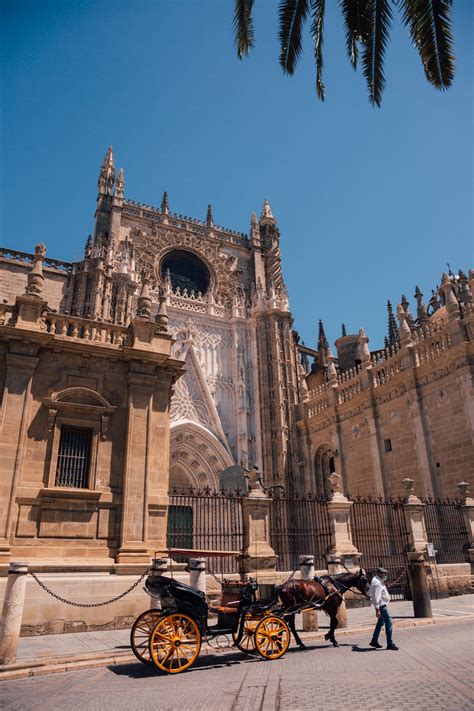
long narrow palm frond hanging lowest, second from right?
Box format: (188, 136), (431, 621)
(362, 0), (392, 107)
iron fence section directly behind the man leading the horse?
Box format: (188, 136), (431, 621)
(351, 497), (410, 600)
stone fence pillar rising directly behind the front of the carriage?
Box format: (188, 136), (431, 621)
(242, 469), (278, 573)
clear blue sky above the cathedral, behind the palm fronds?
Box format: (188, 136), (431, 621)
(0, 0), (473, 348)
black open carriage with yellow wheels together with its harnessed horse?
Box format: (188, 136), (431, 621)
(130, 550), (370, 674)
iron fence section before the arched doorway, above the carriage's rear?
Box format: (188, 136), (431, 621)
(167, 489), (244, 574)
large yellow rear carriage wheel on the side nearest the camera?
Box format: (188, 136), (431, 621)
(150, 613), (201, 674)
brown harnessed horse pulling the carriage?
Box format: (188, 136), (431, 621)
(278, 568), (368, 649)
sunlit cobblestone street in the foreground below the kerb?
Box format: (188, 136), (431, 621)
(0, 620), (474, 711)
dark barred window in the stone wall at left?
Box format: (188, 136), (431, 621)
(56, 425), (93, 489)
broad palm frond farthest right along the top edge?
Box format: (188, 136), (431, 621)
(402, 0), (454, 89)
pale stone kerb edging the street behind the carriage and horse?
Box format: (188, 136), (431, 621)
(0, 614), (474, 682)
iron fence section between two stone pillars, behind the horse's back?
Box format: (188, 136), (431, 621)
(270, 492), (331, 571)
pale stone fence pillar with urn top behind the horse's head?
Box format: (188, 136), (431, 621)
(326, 472), (361, 627)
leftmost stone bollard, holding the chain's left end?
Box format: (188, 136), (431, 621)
(0, 563), (28, 664)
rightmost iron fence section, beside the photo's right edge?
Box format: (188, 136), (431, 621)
(423, 498), (469, 563)
